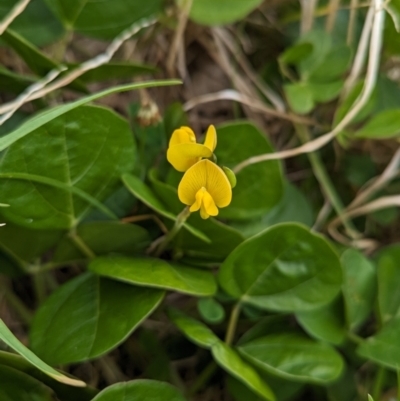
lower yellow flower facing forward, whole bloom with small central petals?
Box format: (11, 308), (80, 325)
(178, 158), (232, 219)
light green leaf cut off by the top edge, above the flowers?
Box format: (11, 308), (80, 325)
(189, 0), (263, 25)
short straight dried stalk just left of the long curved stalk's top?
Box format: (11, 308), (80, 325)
(342, 1), (375, 97)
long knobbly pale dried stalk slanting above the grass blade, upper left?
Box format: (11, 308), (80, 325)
(0, 18), (156, 120)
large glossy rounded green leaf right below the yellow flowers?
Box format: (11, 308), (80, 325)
(218, 223), (342, 312)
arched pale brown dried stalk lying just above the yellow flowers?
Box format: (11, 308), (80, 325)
(183, 89), (317, 126)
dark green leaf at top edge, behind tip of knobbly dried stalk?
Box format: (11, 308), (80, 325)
(73, 0), (162, 40)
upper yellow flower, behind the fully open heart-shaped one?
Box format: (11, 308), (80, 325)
(167, 125), (217, 172)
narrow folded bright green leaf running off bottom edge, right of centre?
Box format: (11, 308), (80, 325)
(211, 341), (275, 401)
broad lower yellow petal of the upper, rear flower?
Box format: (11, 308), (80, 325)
(167, 143), (212, 172)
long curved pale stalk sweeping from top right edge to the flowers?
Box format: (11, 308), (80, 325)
(233, 0), (385, 173)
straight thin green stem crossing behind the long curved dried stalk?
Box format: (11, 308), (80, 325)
(294, 123), (359, 238)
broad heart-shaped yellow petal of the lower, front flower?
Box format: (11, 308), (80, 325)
(178, 159), (232, 207)
